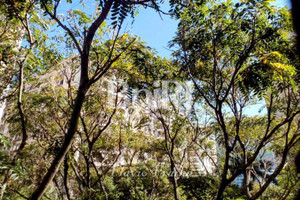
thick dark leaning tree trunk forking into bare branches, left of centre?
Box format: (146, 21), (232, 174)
(20, 0), (170, 199)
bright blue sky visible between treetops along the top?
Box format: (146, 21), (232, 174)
(54, 0), (290, 58)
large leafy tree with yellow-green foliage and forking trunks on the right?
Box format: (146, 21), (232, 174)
(173, 1), (300, 199)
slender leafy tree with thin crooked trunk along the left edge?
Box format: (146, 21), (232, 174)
(1, 1), (51, 193)
